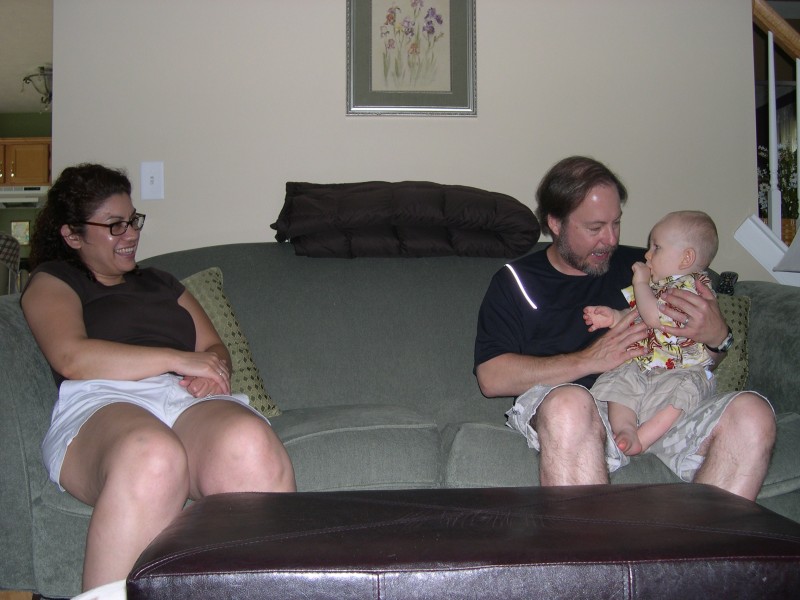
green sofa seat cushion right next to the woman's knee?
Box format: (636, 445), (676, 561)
(271, 404), (439, 491)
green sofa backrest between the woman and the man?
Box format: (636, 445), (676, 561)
(142, 243), (510, 423)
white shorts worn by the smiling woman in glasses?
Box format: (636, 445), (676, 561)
(42, 374), (269, 492)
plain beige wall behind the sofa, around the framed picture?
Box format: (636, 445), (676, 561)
(53, 0), (771, 279)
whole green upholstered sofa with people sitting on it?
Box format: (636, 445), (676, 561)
(0, 243), (800, 597)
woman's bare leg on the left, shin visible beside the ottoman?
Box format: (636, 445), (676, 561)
(61, 403), (189, 590)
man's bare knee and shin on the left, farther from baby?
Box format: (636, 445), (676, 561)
(531, 385), (608, 486)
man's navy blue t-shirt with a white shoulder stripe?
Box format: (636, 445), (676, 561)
(475, 246), (645, 387)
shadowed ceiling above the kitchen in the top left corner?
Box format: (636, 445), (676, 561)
(0, 0), (55, 113)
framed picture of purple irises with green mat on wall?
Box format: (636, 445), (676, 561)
(347, 0), (477, 117)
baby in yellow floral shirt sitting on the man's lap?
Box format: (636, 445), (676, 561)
(583, 210), (730, 455)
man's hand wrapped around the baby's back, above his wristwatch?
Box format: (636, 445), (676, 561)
(661, 285), (728, 348)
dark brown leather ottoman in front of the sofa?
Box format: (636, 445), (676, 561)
(127, 484), (800, 600)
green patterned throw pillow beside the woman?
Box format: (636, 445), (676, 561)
(181, 267), (281, 417)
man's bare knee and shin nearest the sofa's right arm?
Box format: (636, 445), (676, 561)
(694, 393), (775, 500)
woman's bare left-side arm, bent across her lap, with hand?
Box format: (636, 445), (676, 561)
(21, 273), (230, 394)
